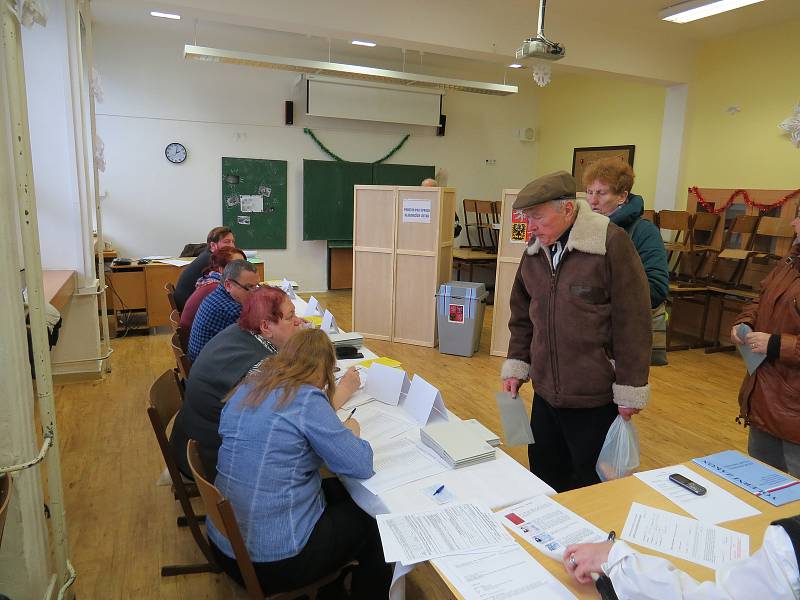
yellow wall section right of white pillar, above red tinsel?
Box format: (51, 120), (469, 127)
(678, 20), (800, 206)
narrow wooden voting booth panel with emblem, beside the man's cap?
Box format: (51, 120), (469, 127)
(489, 190), (528, 357)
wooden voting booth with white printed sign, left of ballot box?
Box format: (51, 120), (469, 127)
(353, 185), (456, 347)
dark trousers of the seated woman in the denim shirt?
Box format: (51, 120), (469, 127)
(211, 477), (392, 600)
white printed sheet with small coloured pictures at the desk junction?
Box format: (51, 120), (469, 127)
(498, 496), (608, 561)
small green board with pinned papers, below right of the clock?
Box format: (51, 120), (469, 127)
(222, 156), (286, 250)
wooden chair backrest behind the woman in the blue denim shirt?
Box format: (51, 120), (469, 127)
(186, 440), (264, 600)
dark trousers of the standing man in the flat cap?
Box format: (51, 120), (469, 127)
(528, 394), (619, 492)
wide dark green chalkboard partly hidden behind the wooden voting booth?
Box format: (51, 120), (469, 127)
(303, 160), (435, 240)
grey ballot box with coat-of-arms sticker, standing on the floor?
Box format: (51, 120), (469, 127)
(436, 281), (489, 356)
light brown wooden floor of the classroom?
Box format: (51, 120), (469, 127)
(56, 291), (746, 600)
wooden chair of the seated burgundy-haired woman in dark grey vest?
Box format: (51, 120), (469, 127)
(147, 370), (221, 577)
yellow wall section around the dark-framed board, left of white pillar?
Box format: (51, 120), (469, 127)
(535, 72), (665, 206)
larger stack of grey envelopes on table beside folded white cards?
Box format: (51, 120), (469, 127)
(419, 421), (496, 469)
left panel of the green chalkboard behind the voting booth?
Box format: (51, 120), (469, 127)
(303, 160), (372, 240)
